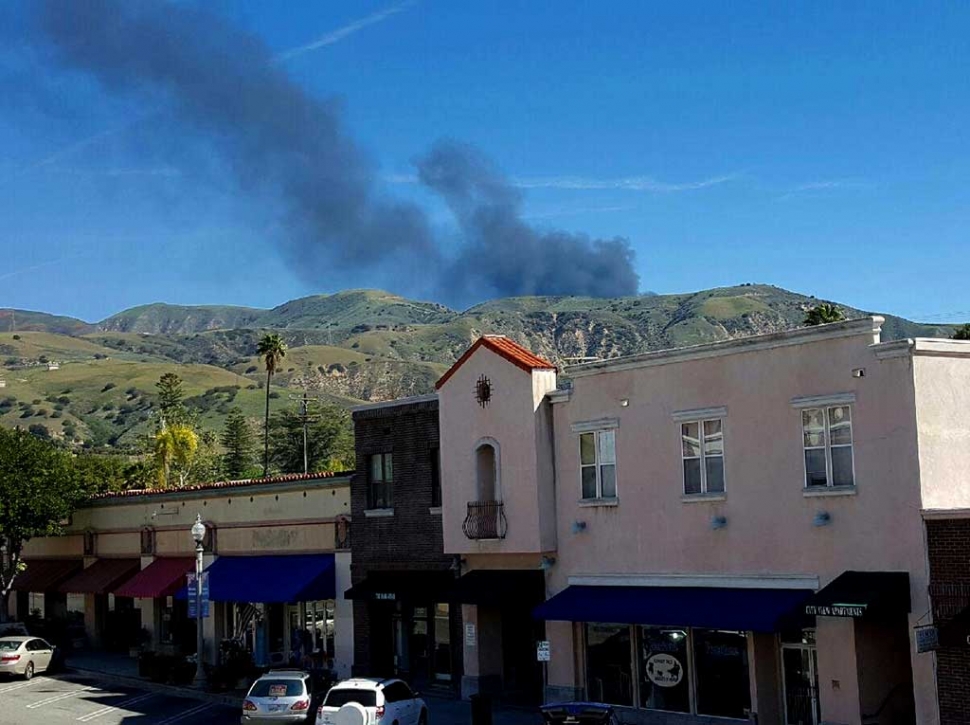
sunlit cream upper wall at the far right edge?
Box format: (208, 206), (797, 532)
(913, 340), (970, 509)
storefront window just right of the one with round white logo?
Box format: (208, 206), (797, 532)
(693, 629), (751, 718)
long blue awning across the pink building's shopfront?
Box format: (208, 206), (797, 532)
(533, 586), (812, 632)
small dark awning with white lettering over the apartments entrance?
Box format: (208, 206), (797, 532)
(804, 571), (911, 619)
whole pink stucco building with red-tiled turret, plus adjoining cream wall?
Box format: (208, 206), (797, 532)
(438, 317), (970, 725)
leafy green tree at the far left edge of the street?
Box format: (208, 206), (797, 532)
(0, 429), (88, 621)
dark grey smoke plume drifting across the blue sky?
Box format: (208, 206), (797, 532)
(33, 0), (638, 302)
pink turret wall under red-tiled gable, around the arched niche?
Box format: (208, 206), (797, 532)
(438, 347), (555, 554)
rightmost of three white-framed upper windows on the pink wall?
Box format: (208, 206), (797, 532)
(802, 405), (855, 488)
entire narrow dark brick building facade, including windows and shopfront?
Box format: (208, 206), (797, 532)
(346, 395), (462, 690)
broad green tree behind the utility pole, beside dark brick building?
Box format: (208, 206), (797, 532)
(270, 405), (354, 473)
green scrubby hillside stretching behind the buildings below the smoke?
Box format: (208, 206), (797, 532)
(0, 285), (952, 446)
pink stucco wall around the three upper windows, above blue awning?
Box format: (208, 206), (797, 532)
(549, 329), (936, 722)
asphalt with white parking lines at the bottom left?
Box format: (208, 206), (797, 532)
(0, 675), (240, 725)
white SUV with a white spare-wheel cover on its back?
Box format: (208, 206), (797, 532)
(317, 677), (428, 725)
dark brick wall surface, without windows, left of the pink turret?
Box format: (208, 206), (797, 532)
(350, 400), (462, 682)
